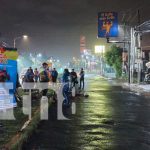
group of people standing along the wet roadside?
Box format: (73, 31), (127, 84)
(24, 62), (85, 106)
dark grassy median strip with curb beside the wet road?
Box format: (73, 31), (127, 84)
(0, 90), (54, 150)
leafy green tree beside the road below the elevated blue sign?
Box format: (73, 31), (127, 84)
(105, 45), (122, 77)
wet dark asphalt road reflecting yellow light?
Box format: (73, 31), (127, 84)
(24, 77), (150, 150)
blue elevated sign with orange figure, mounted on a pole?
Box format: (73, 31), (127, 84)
(98, 12), (118, 37)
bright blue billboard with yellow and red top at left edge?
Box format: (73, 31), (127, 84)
(0, 48), (18, 108)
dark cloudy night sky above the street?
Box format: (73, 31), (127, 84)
(0, 0), (150, 61)
